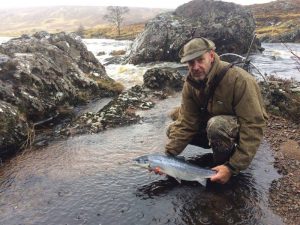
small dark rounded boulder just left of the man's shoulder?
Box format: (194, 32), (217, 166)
(143, 68), (184, 91)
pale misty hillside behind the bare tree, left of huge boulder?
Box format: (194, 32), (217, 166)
(0, 6), (168, 36)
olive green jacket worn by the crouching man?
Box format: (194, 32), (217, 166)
(165, 54), (268, 171)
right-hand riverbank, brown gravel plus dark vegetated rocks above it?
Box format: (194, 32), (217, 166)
(261, 77), (300, 225)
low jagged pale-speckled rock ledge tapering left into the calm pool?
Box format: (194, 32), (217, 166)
(61, 85), (155, 135)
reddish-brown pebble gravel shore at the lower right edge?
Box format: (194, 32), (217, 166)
(265, 114), (300, 225)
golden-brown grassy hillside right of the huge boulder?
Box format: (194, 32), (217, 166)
(247, 0), (300, 42)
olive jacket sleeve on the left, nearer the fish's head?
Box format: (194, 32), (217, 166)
(165, 82), (200, 155)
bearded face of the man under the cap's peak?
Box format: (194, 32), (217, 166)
(188, 51), (215, 81)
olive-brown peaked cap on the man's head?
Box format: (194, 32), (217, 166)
(179, 37), (216, 63)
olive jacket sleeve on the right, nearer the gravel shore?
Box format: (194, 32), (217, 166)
(229, 76), (267, 172)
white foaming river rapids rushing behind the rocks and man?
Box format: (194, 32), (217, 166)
(0, 37), (300, 85)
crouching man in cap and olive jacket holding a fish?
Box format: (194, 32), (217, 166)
(165, 38), (267, 184)
